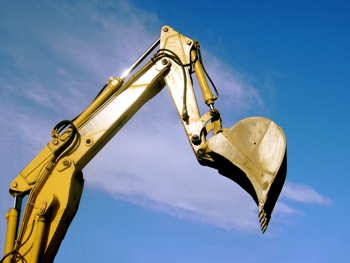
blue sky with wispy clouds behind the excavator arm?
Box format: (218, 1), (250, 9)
(0, 0), (350, 262)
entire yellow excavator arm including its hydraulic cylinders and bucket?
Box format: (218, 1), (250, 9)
(1, 26), (286, 262)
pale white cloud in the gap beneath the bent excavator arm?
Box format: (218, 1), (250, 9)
(84, 108), (259, 231)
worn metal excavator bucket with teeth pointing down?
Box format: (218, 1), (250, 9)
(200, 117), (287, 233)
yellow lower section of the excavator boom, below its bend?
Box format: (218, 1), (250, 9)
(7, 158), (84, 262)
